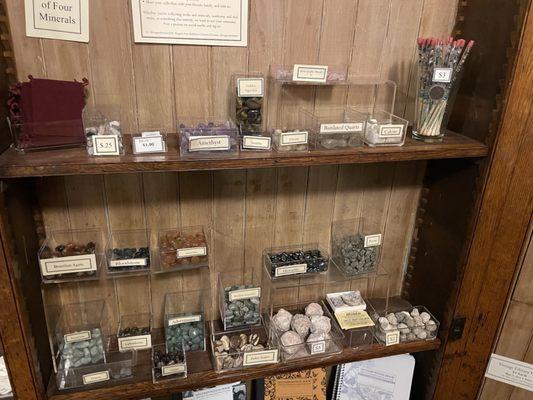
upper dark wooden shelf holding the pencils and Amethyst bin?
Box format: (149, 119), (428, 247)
(0, 132), (488, 178)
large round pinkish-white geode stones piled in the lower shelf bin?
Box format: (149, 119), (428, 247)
(271, 303), (331, 357)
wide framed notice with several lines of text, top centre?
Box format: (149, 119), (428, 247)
(131, 0), (248, 46)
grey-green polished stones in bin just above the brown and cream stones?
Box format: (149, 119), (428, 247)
(224, 285), (261, 329)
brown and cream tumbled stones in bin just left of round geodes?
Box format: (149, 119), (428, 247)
(213, 333), (267, 370)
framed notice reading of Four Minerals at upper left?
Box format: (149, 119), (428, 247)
(24, 0), (89, 42)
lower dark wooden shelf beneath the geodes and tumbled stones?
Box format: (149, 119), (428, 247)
(48, 339), (440, 400)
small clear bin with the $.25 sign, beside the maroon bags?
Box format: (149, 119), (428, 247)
(82, 106), (124, 157)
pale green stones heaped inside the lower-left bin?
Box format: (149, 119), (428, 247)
(59, 328), (104, 369)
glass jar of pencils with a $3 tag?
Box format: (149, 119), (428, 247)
(413, 37), (474, 142)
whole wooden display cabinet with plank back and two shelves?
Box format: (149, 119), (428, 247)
(0, 0), (533, 400)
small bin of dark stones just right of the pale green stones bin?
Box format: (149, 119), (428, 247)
(117, 313), (152, 352)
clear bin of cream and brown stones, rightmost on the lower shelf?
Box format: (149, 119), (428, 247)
(371, 306), (440, 346)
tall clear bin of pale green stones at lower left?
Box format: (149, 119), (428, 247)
(49, 300), (108, 371)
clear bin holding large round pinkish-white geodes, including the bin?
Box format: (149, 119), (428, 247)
(268, 301), (344, 361)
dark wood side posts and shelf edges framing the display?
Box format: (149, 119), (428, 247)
(0, 0), (533, 399)
